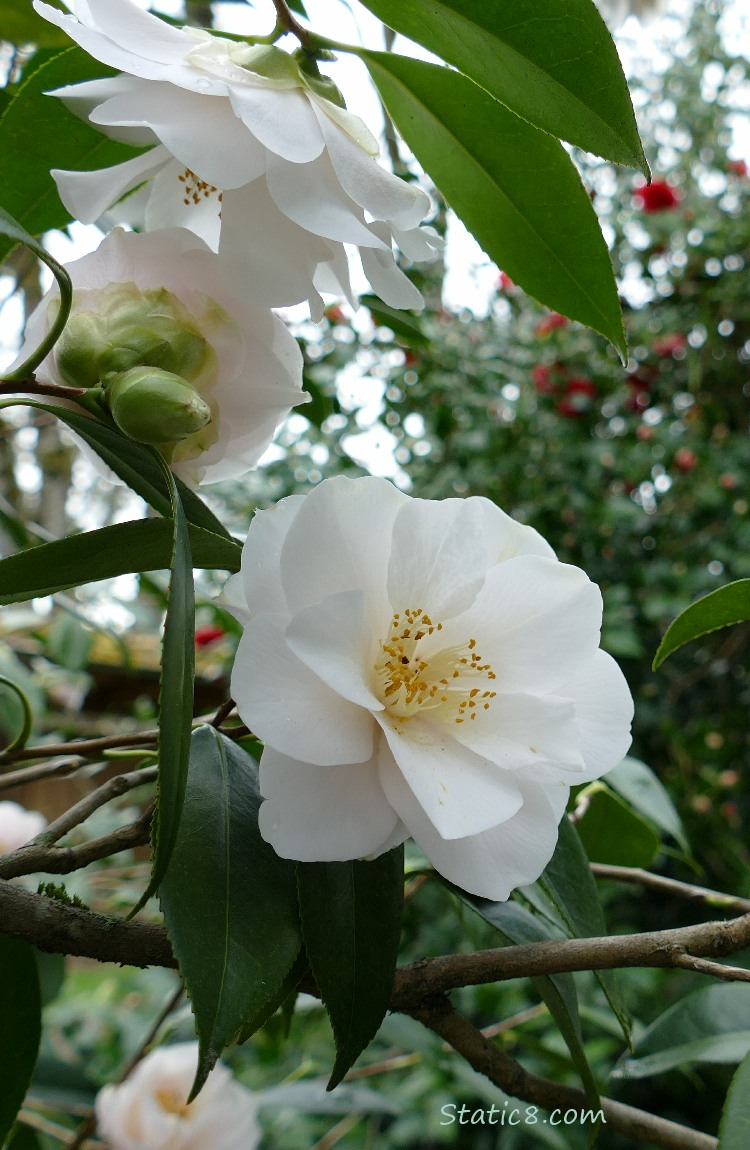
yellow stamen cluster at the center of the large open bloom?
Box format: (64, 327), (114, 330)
(375, 607), (497, 723)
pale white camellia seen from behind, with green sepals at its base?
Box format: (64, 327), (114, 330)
(16, 228), (309, 484)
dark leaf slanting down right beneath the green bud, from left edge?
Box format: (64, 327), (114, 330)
(0, 397), (231, 539)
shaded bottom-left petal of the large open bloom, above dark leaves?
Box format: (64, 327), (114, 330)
(259, 748), (398, 863)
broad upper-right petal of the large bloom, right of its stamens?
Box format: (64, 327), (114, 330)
(433, 555), (602, 696)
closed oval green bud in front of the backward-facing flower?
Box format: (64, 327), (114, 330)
(105, 367), (211, 446)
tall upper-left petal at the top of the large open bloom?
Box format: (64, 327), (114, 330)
(281, 476), (410, 629)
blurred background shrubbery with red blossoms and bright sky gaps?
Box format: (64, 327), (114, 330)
(0, 0), (750, 1150)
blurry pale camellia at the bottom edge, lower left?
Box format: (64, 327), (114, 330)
(95, 1042), (260, 1150)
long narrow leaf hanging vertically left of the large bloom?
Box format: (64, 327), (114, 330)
(131, 451), (196, 915)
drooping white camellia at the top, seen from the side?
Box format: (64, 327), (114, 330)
(35, 0), (439, 317)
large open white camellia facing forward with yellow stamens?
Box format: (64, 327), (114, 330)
(227, 477), (633, 900)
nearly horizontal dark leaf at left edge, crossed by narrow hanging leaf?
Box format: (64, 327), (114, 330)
(0, 519), (242, 606)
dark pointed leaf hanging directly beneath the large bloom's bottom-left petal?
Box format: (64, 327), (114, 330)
(297, 846), (404, 1090)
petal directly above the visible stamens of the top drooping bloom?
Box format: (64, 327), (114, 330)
(89, 81), (266, 189)
